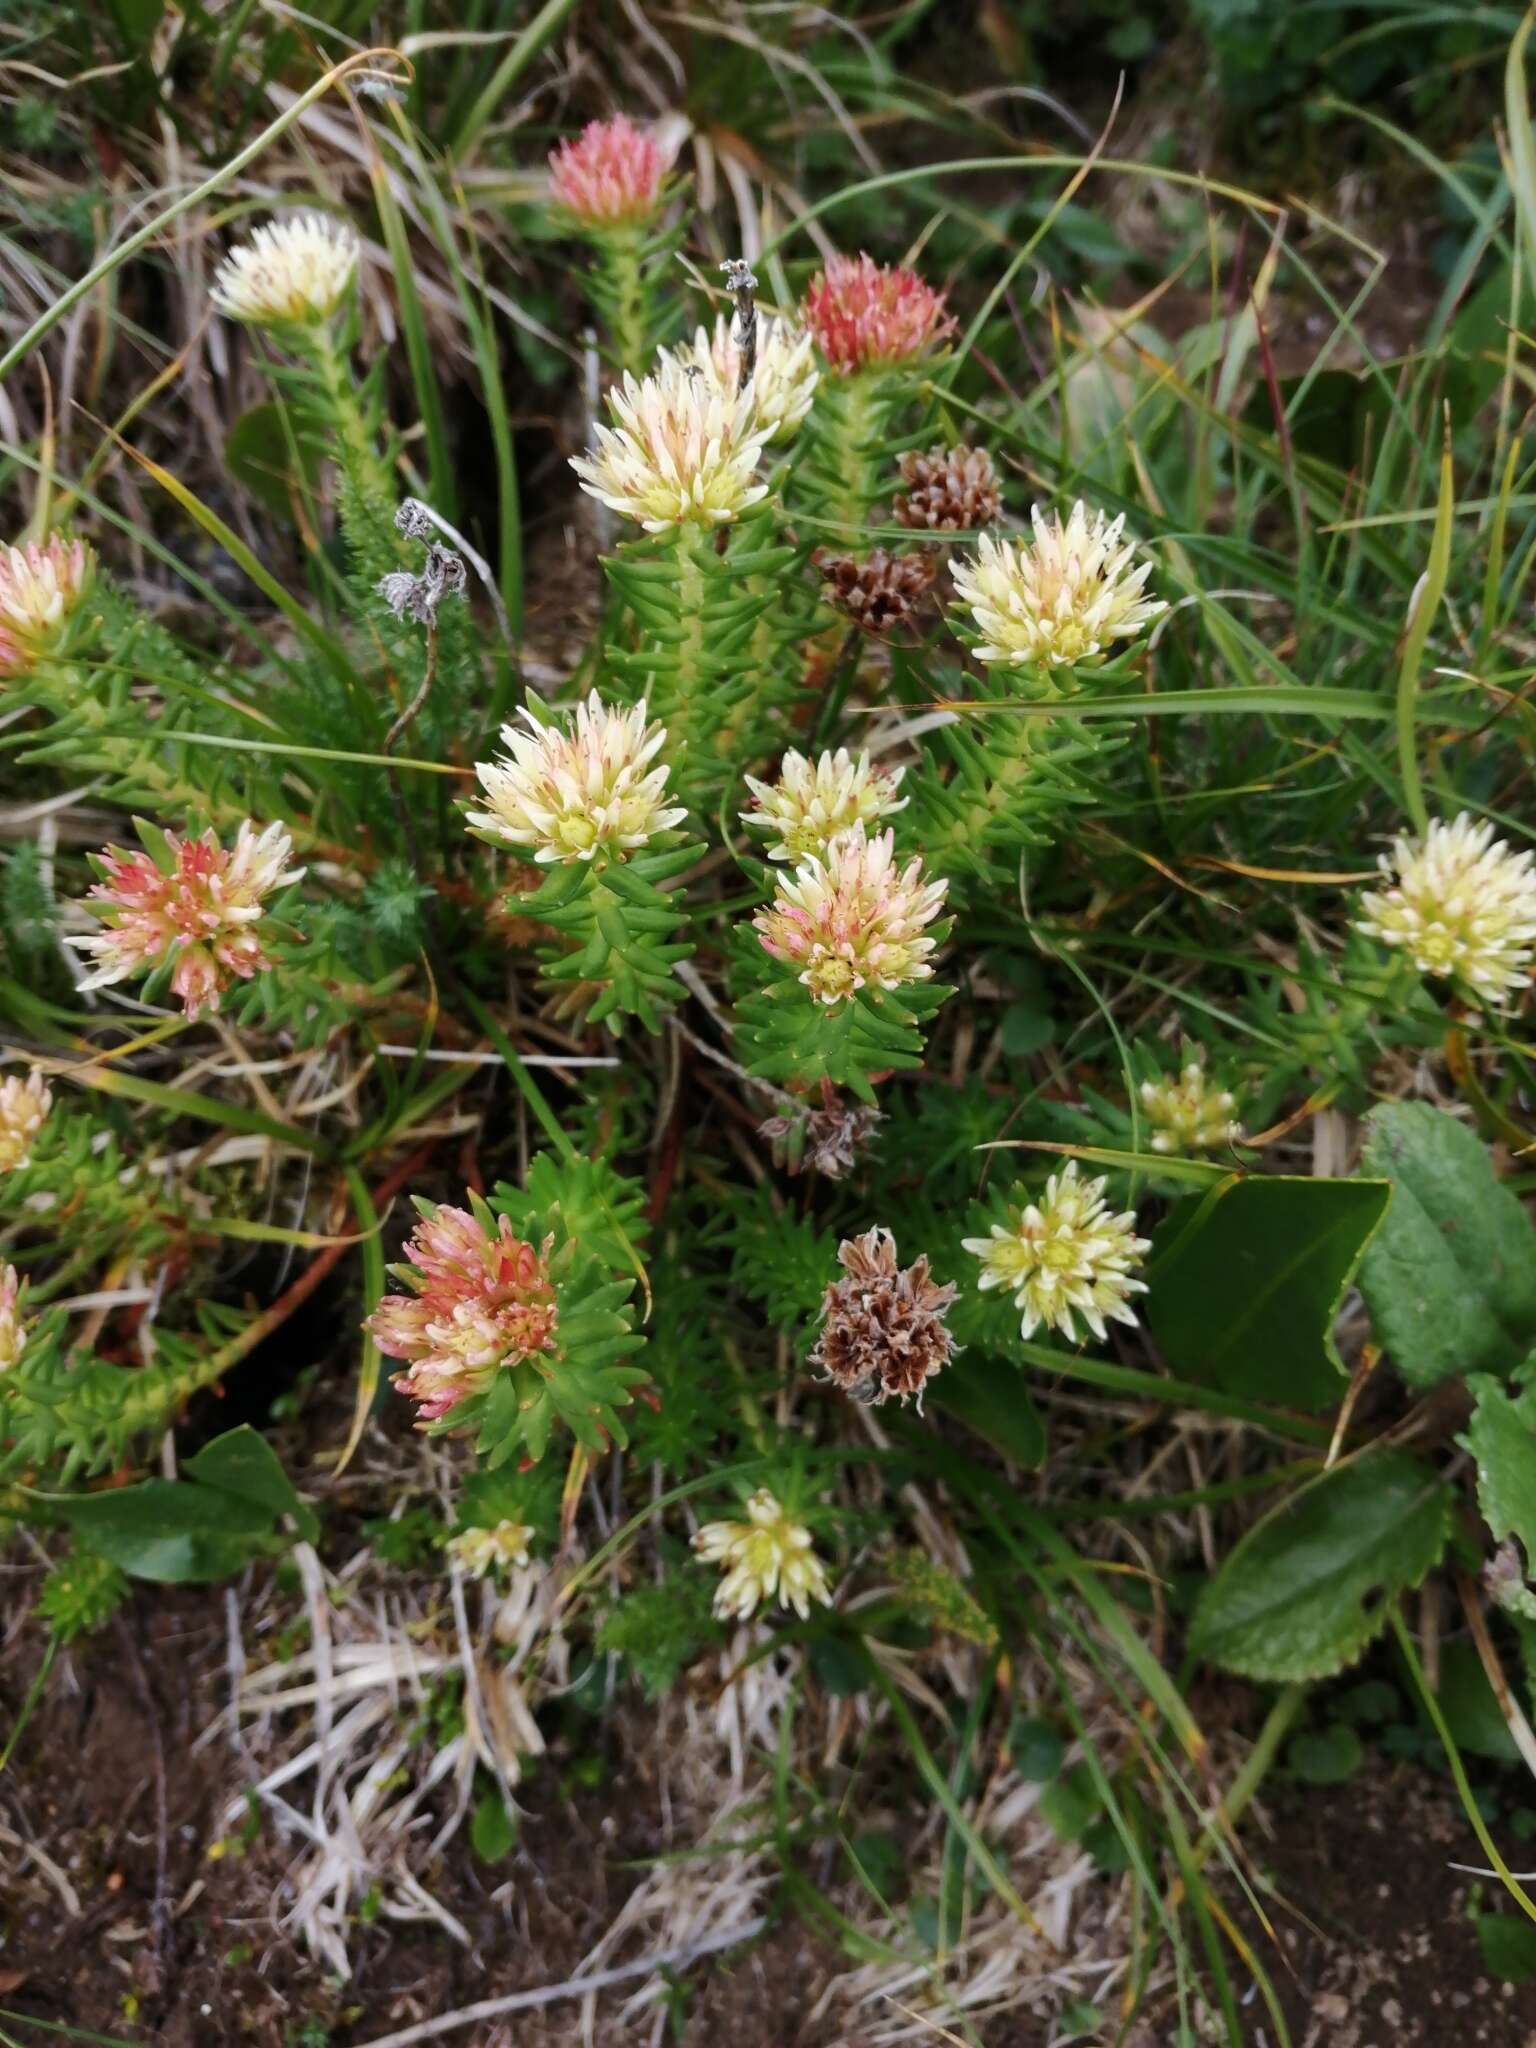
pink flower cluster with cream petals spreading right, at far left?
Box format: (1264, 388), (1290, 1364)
(74, 819), (303, 1018)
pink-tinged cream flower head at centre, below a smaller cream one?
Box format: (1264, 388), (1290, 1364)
(752, 825), (948, 1006)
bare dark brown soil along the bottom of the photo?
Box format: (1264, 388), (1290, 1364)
(0, 1589), (1536, 2048)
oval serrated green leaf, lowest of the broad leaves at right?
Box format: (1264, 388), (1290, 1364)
(1190, 1450), (1450, 1681)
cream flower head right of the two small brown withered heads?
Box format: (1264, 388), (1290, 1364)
(952, 498), (1167, 668)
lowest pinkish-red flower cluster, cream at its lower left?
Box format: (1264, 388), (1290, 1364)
(367, 1206), (559, 1421)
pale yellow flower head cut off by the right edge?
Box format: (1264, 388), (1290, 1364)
(1358, 811), (1536, 1006)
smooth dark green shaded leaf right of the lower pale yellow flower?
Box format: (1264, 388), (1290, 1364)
(1147, 1174), (1391, 1409)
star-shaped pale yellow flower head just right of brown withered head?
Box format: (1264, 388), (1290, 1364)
(963, 1159), (1151, 1343)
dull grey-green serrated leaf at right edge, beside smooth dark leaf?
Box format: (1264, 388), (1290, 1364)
(1360, 1102), (1536, 1386)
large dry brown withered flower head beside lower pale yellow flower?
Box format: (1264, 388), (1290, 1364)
(811, 1225), (956, 1411)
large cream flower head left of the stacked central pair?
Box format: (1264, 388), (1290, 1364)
(469, 690), (686, 866)
